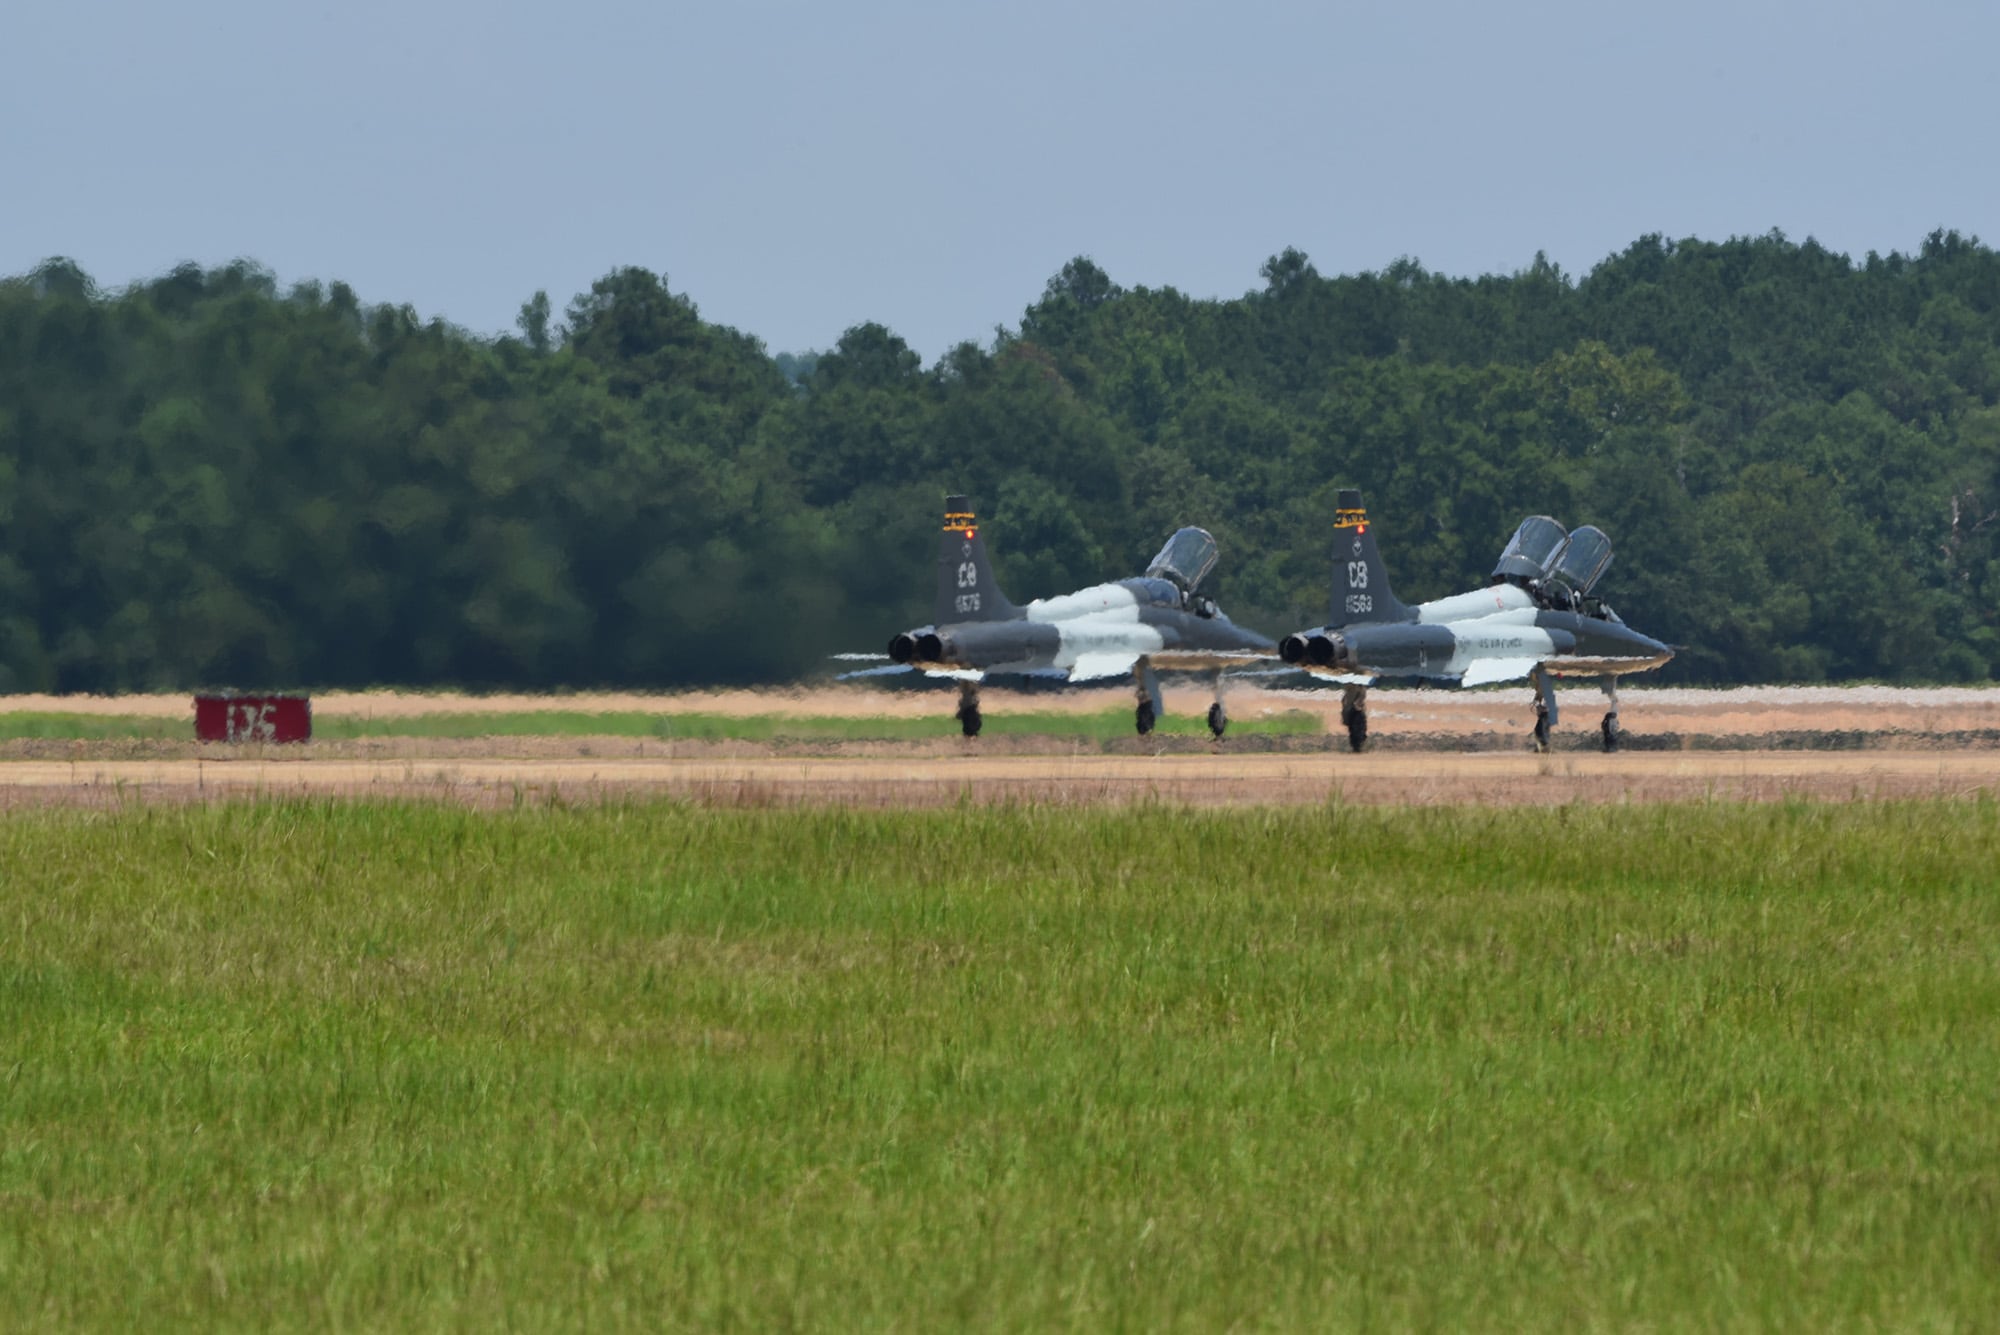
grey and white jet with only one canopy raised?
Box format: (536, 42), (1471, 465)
(856, 496), (1274, 737)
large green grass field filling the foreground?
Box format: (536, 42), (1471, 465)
(0, 801), (2000, 1331)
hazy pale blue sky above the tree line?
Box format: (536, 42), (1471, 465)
(0, 0), (2000, 360)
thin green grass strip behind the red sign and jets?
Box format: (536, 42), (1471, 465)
(0, 695), (1326, 741)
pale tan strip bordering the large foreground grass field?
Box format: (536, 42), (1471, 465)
(0, 751), (2000, 807)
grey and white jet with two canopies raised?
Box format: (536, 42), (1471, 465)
(1278, 492), (1674, 751)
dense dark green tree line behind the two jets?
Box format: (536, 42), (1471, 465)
(11, 232), (2000, 689)
